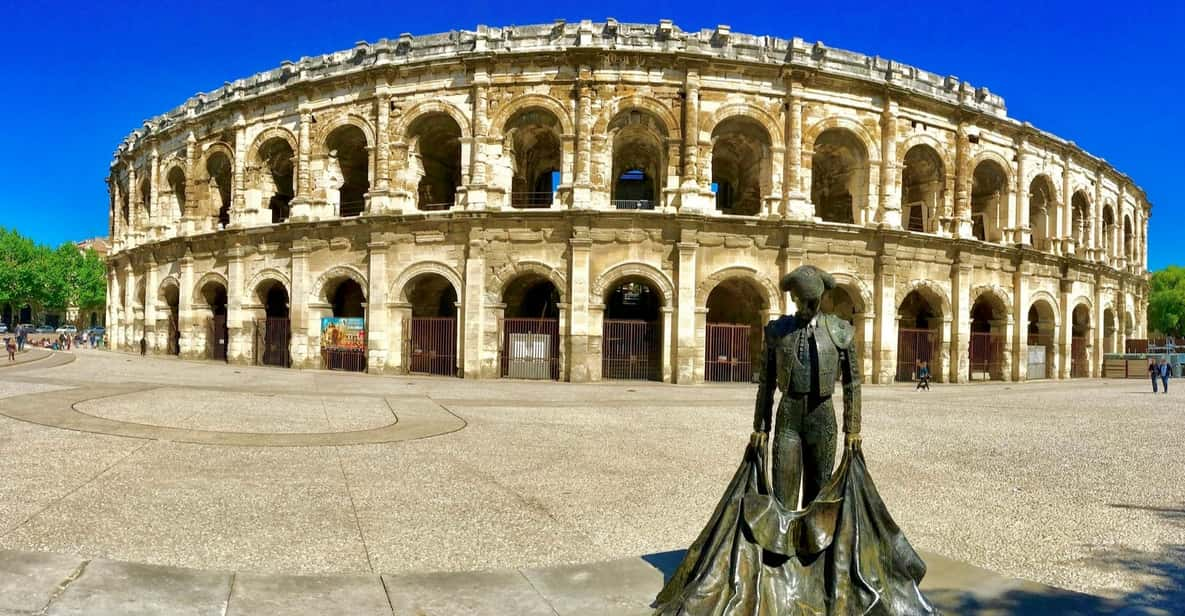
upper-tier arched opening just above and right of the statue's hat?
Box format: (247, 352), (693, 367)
(811, 128), (869, 224)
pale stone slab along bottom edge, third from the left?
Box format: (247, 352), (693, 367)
(225, 573), (391, 616)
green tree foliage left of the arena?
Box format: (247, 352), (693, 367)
(0, 227), (107, 310)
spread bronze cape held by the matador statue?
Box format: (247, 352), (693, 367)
(654, 445), (937, 616)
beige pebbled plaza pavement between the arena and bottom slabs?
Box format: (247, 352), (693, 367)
(0, 351), (1185, 612)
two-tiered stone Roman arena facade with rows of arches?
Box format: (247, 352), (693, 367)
(108, 20), (1151, 383)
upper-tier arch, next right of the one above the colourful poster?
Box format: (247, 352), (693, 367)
(408, 113), (461, 211)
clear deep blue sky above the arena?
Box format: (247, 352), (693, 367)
(0, 0), (1185, 269)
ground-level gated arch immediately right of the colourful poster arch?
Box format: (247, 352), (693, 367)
(404, 274), (460, 377)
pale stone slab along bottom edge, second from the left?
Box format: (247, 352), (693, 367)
(46, 560), (231, 616)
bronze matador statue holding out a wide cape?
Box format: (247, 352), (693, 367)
(654, 265), (937, 616)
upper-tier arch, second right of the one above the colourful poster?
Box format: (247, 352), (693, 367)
(504, 108), (562, 207)
